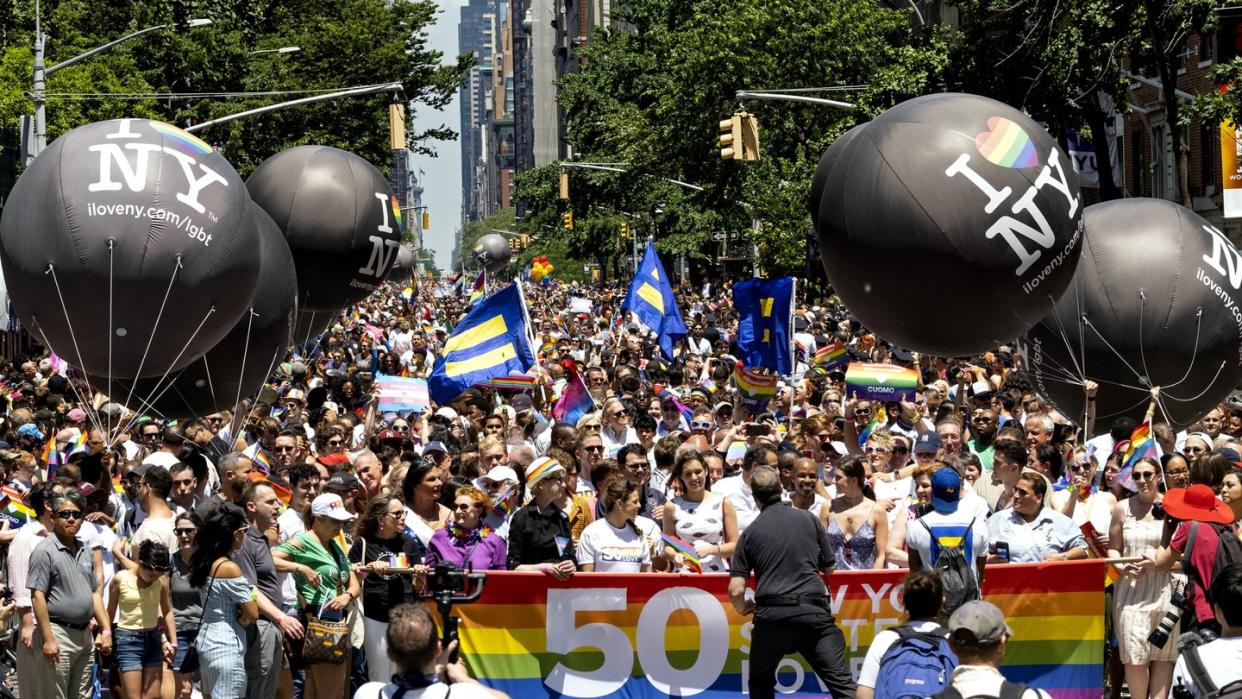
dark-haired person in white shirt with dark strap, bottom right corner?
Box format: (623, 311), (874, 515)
(1172, 565), (1242, 697)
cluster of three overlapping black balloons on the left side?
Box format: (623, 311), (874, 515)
(0, 119), (401, 418)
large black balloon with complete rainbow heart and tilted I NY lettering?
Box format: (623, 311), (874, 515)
(810, 94), (1082, 356)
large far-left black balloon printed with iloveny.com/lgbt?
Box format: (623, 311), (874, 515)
(0, 119), (258, 377)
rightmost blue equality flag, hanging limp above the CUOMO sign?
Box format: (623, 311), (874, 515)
(733, 277), (796, 374)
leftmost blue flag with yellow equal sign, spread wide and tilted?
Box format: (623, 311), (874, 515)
(427, 284), (535, 405)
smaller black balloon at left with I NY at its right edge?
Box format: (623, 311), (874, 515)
(246, 145), (401, 310)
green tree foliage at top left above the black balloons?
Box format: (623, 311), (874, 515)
(0, 0), (472, 176)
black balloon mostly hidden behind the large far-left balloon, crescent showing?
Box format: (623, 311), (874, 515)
(96, 204), (298, 418)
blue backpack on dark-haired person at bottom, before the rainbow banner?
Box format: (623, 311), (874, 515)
(876, 625), (958, 699)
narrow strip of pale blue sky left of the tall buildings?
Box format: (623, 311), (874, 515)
(412, 0), (462, 269)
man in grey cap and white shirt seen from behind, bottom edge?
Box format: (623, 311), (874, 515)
(945, 600), (1049, 699)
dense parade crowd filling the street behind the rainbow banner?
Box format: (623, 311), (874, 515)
(0, 274), (1242, 699)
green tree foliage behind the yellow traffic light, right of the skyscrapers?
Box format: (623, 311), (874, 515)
(517, 0), (946, 276)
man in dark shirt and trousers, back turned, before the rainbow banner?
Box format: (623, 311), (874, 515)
(729, 467), (854, 699)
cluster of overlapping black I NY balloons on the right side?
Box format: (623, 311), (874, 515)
(810, 93), (1242, 428)
